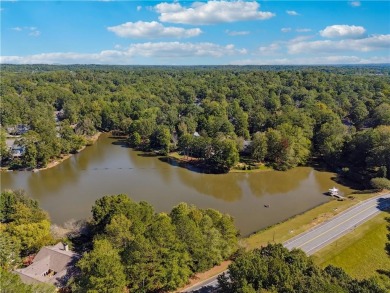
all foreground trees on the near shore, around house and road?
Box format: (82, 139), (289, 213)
(0, 191), (390, 293)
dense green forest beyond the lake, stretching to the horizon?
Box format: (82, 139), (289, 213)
(0, 65), (390, 188)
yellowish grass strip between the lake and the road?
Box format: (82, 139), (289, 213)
(240, 193), (378, 250)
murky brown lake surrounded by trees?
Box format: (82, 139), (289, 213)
(1, 134), (352, 236)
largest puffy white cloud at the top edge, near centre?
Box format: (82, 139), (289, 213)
(155, 1), (275, 24)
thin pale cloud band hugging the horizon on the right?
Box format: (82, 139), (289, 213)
(230, 55), (390, 65)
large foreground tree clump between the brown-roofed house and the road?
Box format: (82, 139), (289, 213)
(75, 194), (238, 292)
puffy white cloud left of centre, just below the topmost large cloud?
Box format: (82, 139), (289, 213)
(107, 21), (202, 39)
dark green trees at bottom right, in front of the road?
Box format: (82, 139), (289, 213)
(218, 244), (385, 293)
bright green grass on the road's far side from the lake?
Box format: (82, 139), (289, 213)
(313, 212), (390, 289)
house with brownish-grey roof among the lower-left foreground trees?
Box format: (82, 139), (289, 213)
(14, 242), (79, 288)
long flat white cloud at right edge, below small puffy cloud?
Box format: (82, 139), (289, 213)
(287, 34), (390, 54)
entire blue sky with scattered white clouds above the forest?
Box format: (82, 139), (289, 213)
(0, 0), (390, 65)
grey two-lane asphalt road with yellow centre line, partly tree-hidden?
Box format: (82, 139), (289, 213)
(184, 193), (390, 293)
